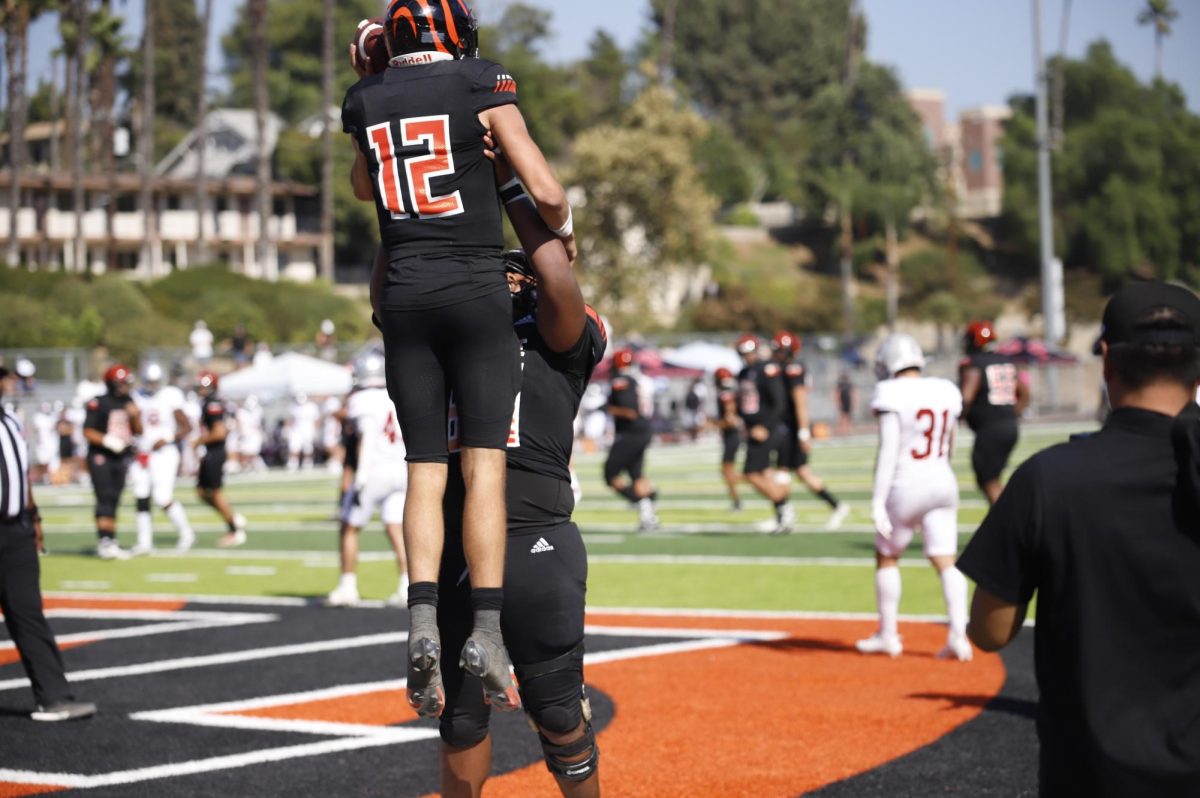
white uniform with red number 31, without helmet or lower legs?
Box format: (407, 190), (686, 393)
(871, 377), (962, 557)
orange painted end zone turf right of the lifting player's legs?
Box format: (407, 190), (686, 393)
(472, 616), (1004, 798)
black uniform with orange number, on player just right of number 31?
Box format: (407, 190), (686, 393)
(961, 352), (1020, 487)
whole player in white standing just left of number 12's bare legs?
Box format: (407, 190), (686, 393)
(325, 353), (408, 607)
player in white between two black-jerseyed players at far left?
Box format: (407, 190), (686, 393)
(130, 362), (196, 554)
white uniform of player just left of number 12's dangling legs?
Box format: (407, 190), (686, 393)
(346, 388), (408, 529)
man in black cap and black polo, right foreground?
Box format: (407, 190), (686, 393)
(959, 282), (1200, 798)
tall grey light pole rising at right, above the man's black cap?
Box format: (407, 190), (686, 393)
(1032, 0), (1066, 408)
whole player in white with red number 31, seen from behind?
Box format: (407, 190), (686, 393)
(857, 334), (971, 661)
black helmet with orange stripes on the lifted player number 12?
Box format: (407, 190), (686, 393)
(383, 0), (479, 59)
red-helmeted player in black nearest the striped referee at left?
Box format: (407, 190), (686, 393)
(83, 364), (142, 559)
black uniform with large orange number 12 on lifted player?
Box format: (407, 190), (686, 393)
(342, 53), (520, 462)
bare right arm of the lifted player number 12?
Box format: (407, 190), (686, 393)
(479, 103), (577, 263)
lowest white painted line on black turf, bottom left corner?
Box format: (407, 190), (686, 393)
(0, 728), (438, 790)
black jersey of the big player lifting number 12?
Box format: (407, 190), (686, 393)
(508, 308), (607, 481)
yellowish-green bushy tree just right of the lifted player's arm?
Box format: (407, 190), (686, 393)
(566, 86), (716, 328)
